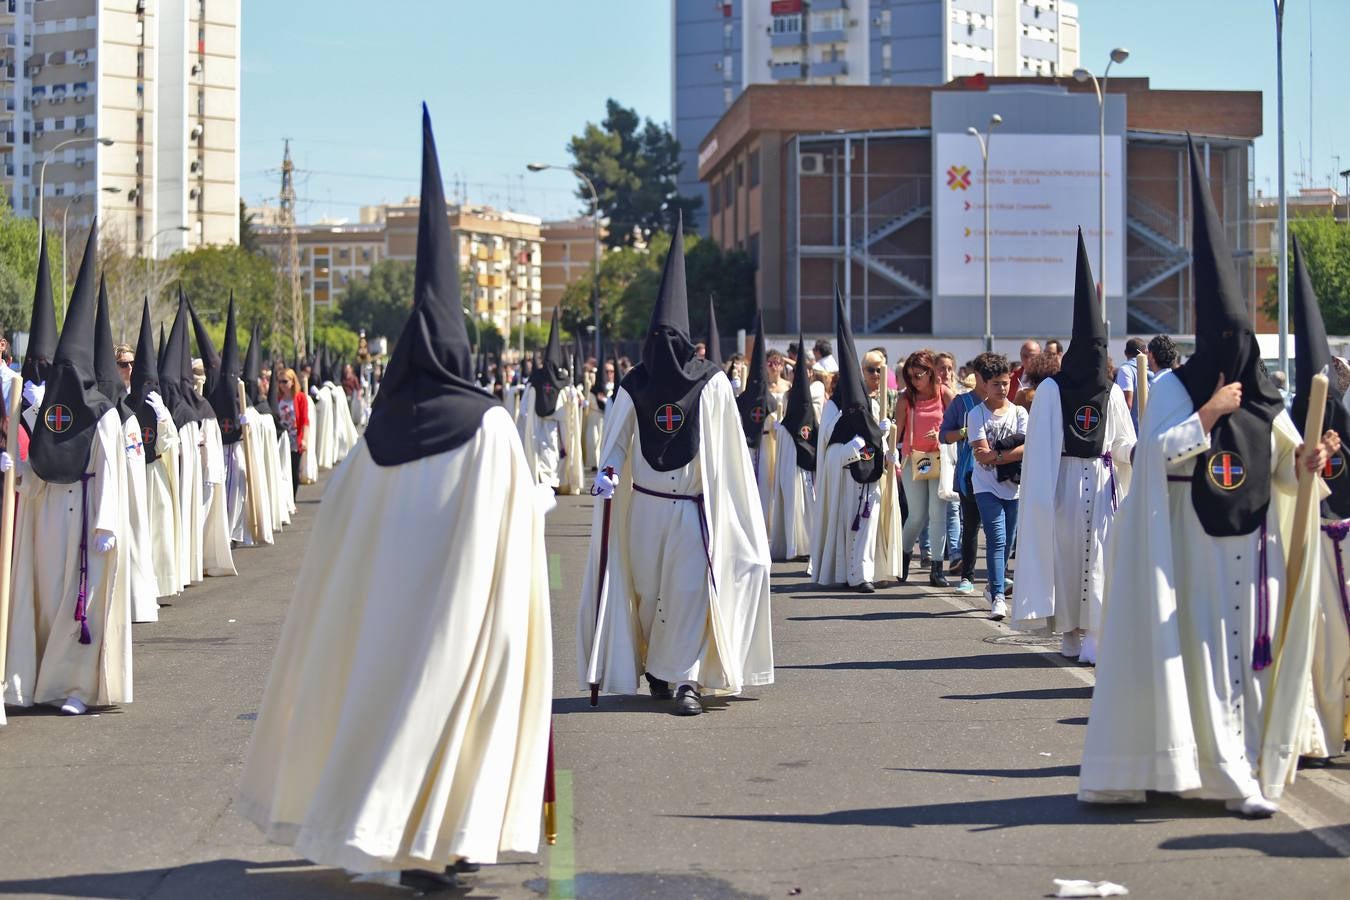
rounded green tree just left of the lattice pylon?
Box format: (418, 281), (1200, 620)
(171, 244), (278, 328)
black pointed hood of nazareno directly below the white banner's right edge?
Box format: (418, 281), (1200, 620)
(1054, 228), (1117, 459)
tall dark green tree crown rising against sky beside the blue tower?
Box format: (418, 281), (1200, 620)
(568, 100), (702, 247)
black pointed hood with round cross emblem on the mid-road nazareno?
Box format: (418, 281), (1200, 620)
(621, 216), (721, 472)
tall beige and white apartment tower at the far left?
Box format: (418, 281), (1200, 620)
(0, 0), (240, 255)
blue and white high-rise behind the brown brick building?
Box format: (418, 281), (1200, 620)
(671, 0), (1079, 229)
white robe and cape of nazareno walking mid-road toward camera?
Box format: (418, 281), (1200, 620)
(576, 374), (774, 695)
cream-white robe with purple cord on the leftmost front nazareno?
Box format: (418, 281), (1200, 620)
(4, 407), (132, 706)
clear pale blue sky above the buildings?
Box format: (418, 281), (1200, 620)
(240, 0), (1350, 221)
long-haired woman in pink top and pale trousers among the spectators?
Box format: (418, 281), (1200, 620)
(895, 349), (953, 587)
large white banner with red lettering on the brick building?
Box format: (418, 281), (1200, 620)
(933, 131), (1125, 297)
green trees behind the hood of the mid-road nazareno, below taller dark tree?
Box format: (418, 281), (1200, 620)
(562, 233), (755, 340)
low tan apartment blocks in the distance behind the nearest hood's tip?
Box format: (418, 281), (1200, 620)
(255, 197), (543, 333)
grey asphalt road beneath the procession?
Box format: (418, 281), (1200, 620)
(0, 488), (1350, 900)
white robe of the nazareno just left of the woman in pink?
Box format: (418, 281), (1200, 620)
(809, 399), (905, 587)
